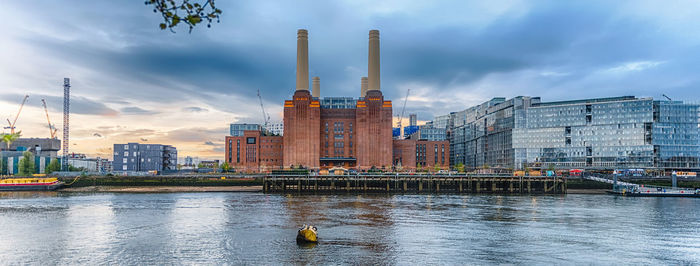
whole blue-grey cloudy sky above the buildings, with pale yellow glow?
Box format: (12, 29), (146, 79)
(0, 0), (700, 158)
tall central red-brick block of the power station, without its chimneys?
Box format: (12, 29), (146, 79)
(284, 90), (392, 170)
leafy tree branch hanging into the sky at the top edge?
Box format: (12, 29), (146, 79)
(145, 0), (222, 33)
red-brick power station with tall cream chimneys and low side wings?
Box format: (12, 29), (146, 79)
(225, 29), (449, 171)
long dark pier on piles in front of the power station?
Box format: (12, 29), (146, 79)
(263, 175), (566, 194)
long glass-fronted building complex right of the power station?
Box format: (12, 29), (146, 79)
(448, 96), (700, 169)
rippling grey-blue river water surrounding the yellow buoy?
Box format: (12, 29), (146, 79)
(0, 192), (700, 265)
